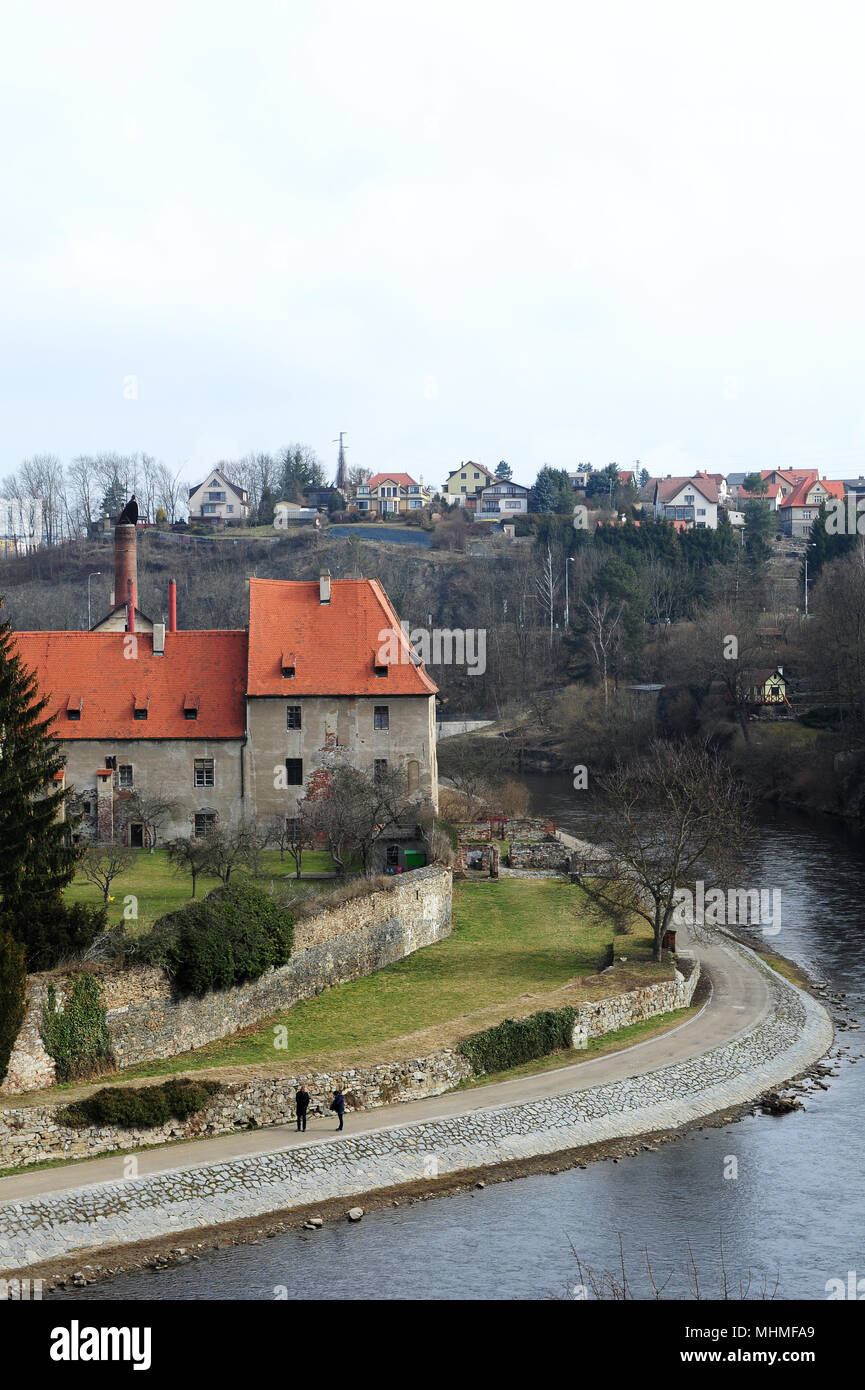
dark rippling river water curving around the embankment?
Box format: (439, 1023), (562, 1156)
(55, 777), (865, 1300)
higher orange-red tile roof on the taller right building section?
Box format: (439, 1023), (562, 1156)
(248, 580), (437, 701)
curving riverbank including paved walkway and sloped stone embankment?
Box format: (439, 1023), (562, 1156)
(0, 940), (833, 1272)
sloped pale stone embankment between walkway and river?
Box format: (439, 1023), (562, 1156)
(0, 942), (833, 1275)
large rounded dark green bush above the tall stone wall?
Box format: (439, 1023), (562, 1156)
(138, 877), (295, 995)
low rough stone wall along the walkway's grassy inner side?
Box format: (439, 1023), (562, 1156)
(0, 958), (700, 1168)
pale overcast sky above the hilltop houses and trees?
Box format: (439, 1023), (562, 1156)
(0, 0), (865, 482)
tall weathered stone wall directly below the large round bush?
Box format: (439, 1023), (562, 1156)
(0, 867), (452, 1094)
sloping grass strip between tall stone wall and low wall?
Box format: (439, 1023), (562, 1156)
(66, 878), (669, 1080)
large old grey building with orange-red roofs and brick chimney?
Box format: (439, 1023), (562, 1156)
(8, 525), (438, 847)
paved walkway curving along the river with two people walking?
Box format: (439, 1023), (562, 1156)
(0, 942), (769, 1205)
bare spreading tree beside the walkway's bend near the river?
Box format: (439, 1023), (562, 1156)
(584, 742), (748, 960)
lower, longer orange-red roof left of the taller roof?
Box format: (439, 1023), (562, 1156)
(15, 631), (246, 738)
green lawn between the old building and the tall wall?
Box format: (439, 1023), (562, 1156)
(65, 849), (342, 933)
